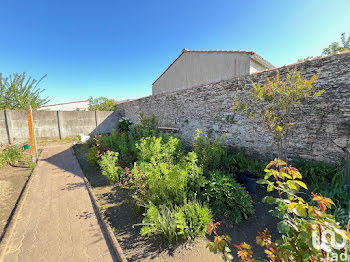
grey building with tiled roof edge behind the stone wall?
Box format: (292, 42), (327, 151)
(152, 49), (273, 95)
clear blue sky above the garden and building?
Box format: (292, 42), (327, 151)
(0, 0), (350, 103)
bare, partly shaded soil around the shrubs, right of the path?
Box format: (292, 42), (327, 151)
(73, 144), (279, 262)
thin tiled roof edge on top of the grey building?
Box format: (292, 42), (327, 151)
(152, 48), (274, 85)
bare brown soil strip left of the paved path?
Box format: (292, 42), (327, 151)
(0, 150), (32, 234)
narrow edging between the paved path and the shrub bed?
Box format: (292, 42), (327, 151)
(70, 147), (128, 262)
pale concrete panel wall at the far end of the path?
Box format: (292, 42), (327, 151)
(0, 110), (121, 144)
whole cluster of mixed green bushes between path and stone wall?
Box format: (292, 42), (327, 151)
(88, 116), (254, 243)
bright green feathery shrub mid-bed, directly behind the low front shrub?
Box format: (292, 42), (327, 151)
(131, 152), (204, 206)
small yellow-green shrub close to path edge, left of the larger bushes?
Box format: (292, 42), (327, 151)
(99, 151), (124, 184)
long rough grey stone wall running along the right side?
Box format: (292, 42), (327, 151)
(119, 52), (350, 162)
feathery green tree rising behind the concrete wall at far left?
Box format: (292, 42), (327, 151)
(0, 73), (49, 109)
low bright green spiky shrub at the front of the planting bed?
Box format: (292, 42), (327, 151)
(141, 201), (212, 243)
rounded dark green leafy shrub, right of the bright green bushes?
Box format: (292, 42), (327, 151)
(201, 171), (254, 224)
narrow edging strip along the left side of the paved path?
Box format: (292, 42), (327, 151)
(0, 157), (42, 261)
